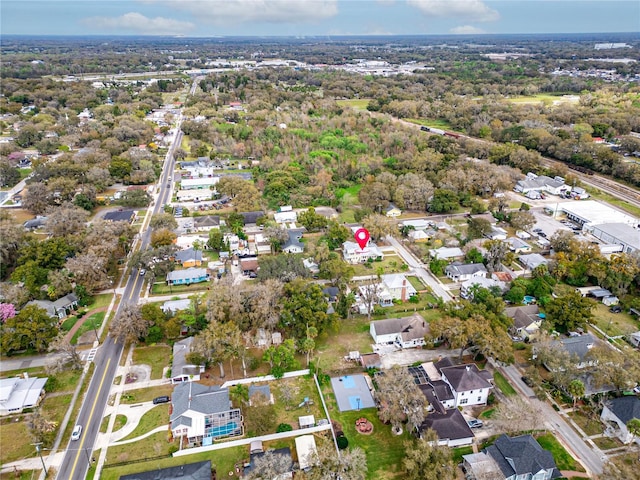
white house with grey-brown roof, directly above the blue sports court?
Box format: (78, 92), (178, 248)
(369, 313), (429, 348)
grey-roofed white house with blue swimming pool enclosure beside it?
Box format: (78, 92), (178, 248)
(169, 382), (243, 445)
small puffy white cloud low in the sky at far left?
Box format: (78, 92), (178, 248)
(82, 12), (195, 35)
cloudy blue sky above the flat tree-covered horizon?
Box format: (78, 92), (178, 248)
(0, 0), (640, 37)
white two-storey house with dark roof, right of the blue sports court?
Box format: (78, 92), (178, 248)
(434, 359), (493, 407)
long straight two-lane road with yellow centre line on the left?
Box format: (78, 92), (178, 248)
(56, 86), (188, 480)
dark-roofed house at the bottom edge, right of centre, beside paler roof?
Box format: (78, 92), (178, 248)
(462, 434), (562, 480)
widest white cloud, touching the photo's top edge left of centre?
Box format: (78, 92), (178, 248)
(142, 0), (338, 25)
